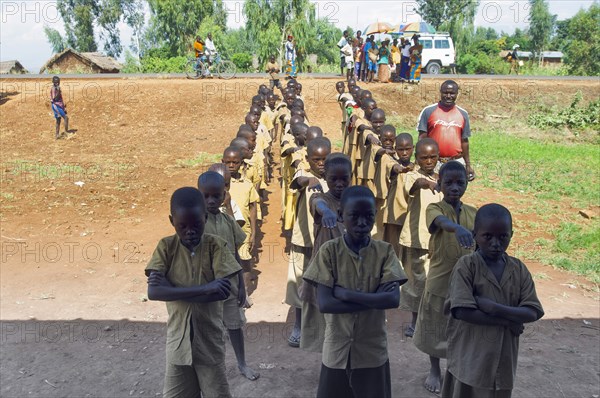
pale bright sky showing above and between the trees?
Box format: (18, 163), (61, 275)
(0, 0), (593, 73)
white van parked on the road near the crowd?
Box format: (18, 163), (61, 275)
(407, 33), (456, 75)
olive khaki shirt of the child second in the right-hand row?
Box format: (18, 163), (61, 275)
(425, 200), (477, 298)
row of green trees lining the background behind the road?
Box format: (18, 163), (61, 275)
(45, 0), (600, 75)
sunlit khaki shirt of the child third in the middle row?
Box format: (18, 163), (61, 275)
(291, 169), (329, 247)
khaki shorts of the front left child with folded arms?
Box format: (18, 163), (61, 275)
(163, 362), (231, 398)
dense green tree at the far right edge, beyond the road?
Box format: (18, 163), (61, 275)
(556, 2), (600, 76)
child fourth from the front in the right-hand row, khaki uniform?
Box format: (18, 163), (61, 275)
(383, 133), (415, 258)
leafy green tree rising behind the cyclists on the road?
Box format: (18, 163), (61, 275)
(144, 0), (227, 56)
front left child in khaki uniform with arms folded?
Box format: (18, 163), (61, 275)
(145, 187), (241, 397)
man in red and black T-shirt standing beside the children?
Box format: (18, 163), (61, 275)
(417, 80), (475, 181)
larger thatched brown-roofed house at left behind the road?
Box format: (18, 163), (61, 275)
(40, 48), (123, 74)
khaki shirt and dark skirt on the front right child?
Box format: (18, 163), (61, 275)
(445, 252), (544, 390)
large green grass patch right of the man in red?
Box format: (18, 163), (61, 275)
(470, 132), (600, 207)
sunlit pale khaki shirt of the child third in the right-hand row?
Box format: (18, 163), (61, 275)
(400, 170), (444, 250)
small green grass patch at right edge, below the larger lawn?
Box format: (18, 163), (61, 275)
(542, 223), (600, 284)
